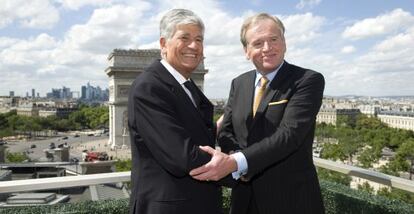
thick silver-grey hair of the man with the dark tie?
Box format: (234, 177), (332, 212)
(160, 9), (204, 40)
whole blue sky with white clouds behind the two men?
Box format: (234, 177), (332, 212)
(0, 0), (414, 98)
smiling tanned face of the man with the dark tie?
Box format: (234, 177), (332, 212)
(160, 24), (203, 79)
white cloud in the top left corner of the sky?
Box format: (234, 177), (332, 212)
(0, 0), (59, 29)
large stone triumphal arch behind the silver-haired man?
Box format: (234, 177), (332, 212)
(105, 49), (208, 148)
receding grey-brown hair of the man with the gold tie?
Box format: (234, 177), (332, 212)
(240, 13), (285, 47)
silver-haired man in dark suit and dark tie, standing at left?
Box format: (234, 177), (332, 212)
(128, 9), (222, 214)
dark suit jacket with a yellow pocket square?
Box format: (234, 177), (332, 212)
(218, 62), (325, 214)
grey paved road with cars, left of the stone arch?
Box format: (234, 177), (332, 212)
(7, 134), (108, 161)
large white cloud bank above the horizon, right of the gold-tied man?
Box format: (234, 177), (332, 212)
(315, 22), (414, 96)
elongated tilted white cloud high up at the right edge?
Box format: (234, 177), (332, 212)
(342, 9), (414, 40)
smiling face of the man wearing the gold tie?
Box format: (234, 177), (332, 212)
(244, 19), (286, 74)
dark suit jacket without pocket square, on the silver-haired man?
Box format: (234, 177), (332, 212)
(128, 61), (221, 214)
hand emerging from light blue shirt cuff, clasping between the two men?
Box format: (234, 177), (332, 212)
(190, 146), (237, 181)
